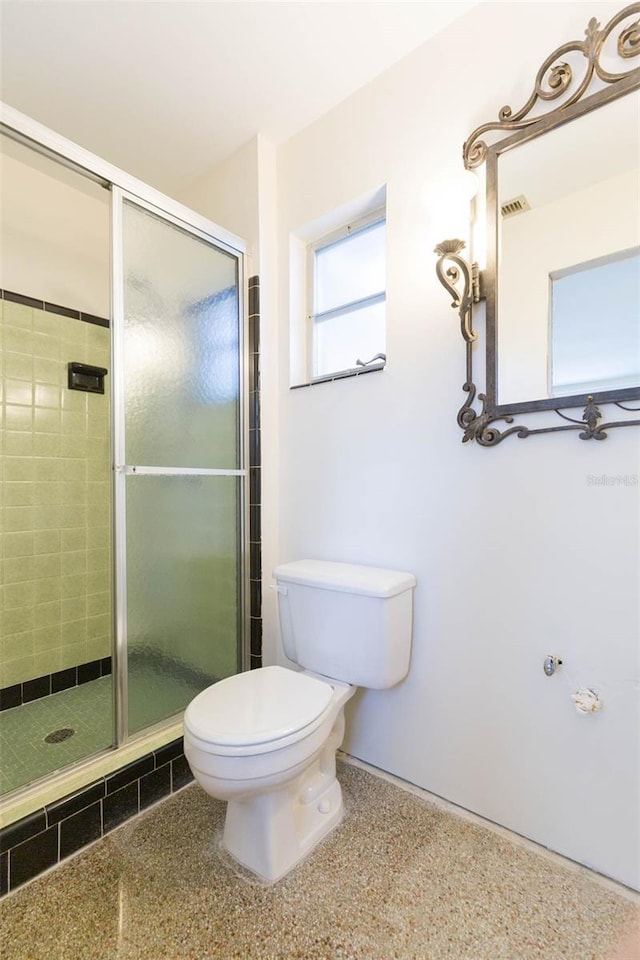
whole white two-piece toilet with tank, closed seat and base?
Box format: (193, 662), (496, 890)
(184, 560), (416, 882)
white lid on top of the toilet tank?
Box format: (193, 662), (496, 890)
(273, 560), (416, 597)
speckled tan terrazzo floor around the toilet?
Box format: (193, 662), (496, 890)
(0, 764), (640, 960)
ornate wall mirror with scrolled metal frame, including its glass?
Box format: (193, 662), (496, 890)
(436, 3), (640, 446)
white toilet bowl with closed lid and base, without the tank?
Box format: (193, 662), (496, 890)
(184, 666), (355, 882)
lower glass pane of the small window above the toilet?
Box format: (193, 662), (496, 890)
(313, 302), (386, 377)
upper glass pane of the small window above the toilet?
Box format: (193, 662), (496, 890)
(315, 220), (385, 313)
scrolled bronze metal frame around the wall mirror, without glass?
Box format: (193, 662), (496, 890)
(435, 3), (640, 447)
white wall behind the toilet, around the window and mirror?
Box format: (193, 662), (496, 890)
(272, 0), (640, 885)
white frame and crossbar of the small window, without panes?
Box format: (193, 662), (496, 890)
(307, 207), (387, 383)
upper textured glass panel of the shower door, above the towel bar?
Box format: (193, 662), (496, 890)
(123, 202), (239, 469)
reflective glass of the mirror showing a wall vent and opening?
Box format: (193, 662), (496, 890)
(496, 91), (640, 404)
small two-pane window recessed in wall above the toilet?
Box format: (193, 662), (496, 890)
(309, 210), (386, 380)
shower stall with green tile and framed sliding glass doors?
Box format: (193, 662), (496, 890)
(0, 108), (249, 799)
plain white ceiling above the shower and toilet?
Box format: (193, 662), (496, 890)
(0, 0), (476, 194)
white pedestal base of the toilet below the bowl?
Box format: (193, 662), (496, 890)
(222, 748), (343, 883)
